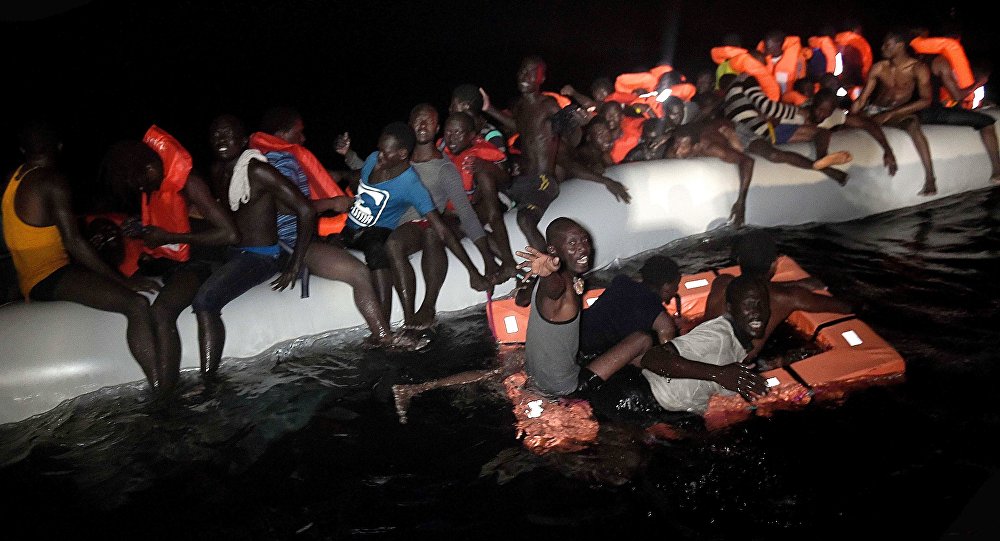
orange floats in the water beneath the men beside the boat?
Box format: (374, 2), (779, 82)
(486, 256), (906, 454)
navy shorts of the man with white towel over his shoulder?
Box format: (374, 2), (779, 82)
(191, 248), (281, 313)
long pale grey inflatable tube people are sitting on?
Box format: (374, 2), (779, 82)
(0, 109), (1000, 423)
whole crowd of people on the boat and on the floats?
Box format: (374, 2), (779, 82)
(2, 21), (1000, 411)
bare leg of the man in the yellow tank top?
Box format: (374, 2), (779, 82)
(53, 266), (160, 389)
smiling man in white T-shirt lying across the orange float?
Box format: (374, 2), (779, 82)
(639, 276), (770, 415)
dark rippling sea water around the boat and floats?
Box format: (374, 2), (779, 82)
(0, 188), (1000, 540)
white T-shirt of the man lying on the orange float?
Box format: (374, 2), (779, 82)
(642, 316), (747, 415)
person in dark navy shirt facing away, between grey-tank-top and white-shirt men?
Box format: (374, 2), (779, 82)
(580, 255), (681, 359)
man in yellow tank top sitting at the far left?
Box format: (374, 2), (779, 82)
(0, 122), (162, 389)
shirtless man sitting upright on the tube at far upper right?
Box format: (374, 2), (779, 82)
(851, 31), (937, 195)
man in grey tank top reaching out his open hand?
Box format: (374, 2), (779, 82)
(517, 217), (654, 396)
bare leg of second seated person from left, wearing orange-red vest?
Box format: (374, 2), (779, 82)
(152, 269), (203, 391)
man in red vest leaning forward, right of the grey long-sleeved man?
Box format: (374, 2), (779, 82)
(444, 112), (517, 285)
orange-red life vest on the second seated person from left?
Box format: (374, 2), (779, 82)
(142, 125), (192, 261)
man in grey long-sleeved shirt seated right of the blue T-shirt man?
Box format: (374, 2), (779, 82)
(386, 103), (499, 330)
